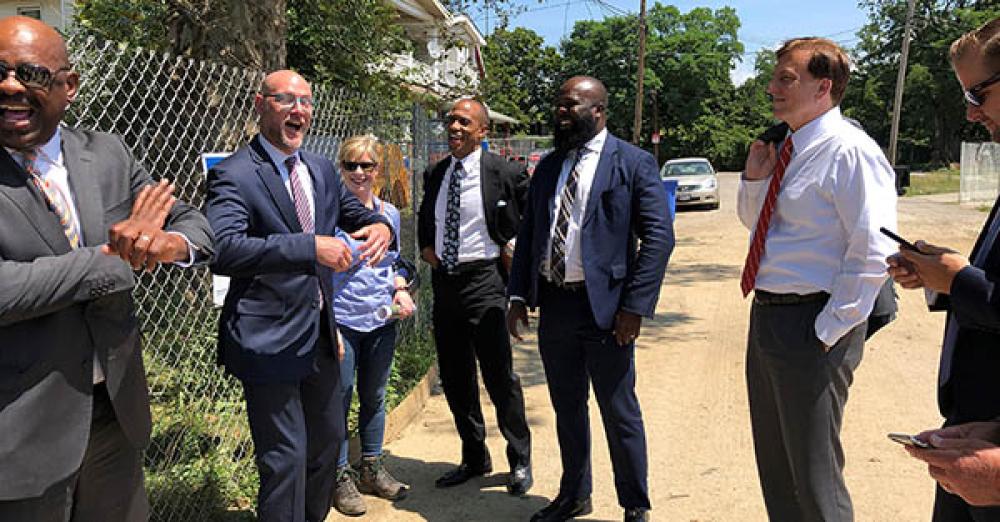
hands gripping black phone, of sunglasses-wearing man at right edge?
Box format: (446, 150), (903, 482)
(886, 241), (969, 294)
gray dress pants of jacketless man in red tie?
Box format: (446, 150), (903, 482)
(746, 291), (867, 522)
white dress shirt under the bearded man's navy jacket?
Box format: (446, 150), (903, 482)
(541, 129), (608, 283)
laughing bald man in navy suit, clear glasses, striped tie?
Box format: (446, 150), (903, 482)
(206, 71), (392, 522)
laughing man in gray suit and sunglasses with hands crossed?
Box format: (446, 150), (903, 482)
(0, 17), (212, 521)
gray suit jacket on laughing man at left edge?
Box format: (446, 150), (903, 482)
(0, 128), (212, 500)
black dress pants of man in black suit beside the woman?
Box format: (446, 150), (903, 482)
(431, 261), (531, 469)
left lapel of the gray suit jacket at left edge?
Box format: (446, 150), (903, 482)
(0, 147), (70, 254)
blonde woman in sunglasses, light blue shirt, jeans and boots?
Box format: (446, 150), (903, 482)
(333, 132), (414, 516)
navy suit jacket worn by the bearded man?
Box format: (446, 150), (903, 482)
(508, 133), (674, 330)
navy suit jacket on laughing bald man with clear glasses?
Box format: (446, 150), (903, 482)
(205, 136), (388, 382)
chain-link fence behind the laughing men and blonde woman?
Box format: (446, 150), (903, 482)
(67, 36), (443, 521)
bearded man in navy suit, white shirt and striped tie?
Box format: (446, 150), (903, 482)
(507, 76), (674, 522)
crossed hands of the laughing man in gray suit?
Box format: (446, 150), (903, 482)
(101, 179), (190, 272)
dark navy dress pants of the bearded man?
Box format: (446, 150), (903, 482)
(538, 282), (651, 509)
